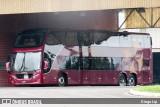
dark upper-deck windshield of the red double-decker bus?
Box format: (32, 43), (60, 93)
(15, 33), (44, 48)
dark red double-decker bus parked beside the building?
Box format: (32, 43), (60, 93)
(6, 29), (153, 86)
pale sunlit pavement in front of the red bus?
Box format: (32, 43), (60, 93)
(0, 86), (152, 98)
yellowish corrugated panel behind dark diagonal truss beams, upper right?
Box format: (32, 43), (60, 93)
(125, 8), (160, 28)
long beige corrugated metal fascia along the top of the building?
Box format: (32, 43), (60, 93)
(0, 0), (160, 14)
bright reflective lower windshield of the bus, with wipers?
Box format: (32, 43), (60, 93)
(11, 52), (41, 72)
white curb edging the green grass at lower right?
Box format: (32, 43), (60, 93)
(130, 89), (160, 97)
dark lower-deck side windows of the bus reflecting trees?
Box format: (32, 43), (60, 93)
(60, 56), (121, 70)
